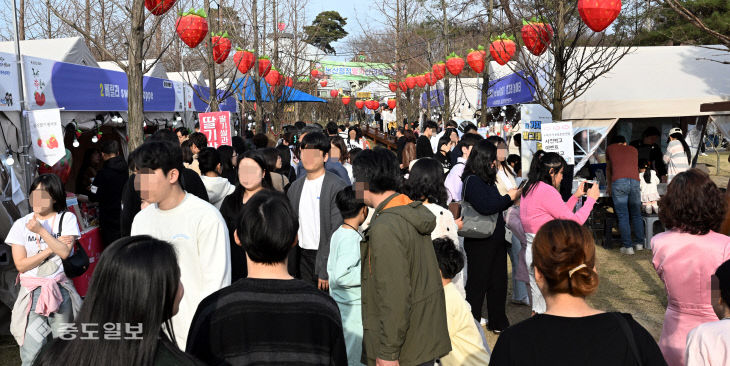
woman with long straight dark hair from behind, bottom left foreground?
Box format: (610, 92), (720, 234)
(34, 235), (188, 366)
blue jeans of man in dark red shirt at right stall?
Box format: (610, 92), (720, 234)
(611, 178), (645, 248)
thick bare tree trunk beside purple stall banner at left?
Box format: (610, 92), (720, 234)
(127, 0), (144, 151)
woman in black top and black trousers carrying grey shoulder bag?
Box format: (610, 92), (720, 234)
(462, 140), (519, 333)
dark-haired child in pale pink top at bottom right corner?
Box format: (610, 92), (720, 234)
(685, 260), (730, 366)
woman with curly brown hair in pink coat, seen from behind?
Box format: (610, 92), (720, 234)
(651, 169), (730, 366)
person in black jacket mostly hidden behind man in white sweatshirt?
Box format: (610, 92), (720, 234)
(120, 129), (208, 237)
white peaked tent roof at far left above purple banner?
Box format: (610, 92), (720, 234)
(0, 37), (99, 67)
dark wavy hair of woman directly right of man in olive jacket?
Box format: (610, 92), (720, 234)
(402, 158), (448, 207)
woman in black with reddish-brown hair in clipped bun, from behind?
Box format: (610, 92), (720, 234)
(489, 220), (666, 366)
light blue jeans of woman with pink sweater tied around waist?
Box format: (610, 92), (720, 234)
(20, 285), (73, 366)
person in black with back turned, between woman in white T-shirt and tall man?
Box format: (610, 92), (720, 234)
(89, 140), (129, 247)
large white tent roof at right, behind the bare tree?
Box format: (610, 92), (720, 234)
(563, 46), (730, 120)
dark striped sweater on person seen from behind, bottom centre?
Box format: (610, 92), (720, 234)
(186, 278), (347, 365)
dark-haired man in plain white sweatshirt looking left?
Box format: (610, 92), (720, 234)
(131, 141), (231, 348)
